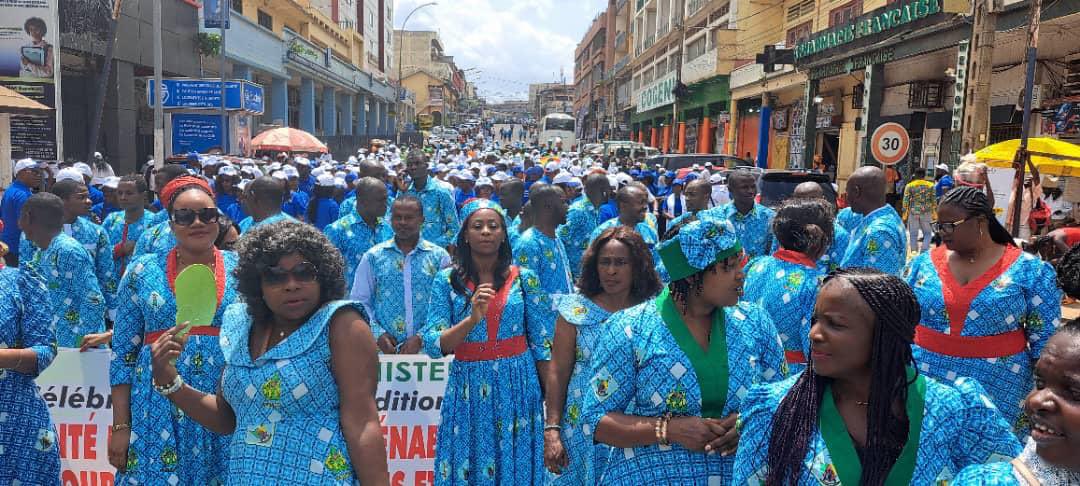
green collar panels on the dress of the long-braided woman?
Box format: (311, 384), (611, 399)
(818, 367), (927, 486)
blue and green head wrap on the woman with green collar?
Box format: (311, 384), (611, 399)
(658, 218), (742, 282)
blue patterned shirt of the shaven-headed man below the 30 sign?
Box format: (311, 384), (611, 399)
(840, 204), (907, 276)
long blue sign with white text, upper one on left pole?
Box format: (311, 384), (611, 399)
(146, 79), (265, 113)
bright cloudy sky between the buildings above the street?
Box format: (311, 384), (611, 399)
(394, 0), (607, 103)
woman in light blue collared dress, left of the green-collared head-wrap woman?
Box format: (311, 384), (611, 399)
(543, 225), (661, 485)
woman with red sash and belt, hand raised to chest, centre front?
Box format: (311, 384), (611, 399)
(420, 199), (555, 485)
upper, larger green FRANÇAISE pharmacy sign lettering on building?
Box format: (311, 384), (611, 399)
(795, 0), (947, 60)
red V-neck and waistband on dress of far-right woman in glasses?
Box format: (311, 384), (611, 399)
(915, 245), (1027, 357)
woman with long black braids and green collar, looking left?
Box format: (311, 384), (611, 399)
(731, 269), (1020, 486)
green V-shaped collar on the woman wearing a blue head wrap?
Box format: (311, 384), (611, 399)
(656, 287), (728, 418)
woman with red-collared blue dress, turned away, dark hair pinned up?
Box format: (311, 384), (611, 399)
(743, 199), (833, 373)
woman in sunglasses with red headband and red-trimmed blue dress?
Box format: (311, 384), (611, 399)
(109, 176), (239, 484)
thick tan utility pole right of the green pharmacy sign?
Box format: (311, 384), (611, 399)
(954, 0), (998, 154)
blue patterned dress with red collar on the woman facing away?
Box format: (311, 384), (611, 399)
(743, 255), (825, 373)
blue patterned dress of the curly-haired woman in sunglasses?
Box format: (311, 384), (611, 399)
(219, 300), (364, 485)
